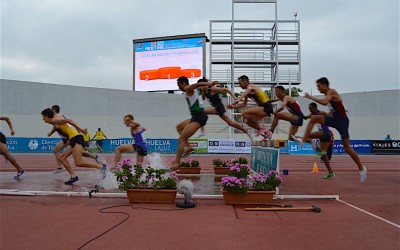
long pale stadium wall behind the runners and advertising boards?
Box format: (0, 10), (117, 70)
(0, 80), (400, 140)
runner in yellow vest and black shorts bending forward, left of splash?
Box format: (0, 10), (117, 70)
(41, 108), (107, 185)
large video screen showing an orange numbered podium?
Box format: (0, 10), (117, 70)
(133, 36), (205, 91)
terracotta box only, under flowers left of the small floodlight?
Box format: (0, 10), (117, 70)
(126, 189), (176, 203)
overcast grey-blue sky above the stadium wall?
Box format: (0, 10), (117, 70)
(0, 0), (400, 93)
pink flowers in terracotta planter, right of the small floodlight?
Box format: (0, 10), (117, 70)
(221, 163), (282, 204)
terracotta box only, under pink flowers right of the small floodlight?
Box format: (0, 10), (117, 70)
(222, 190), (275, 205)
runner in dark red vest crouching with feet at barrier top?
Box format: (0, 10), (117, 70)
(266, 86), (304, 141)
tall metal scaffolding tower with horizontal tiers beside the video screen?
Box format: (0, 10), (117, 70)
(209, 0), (301, 87)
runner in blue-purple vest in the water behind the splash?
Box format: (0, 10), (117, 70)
(115, 114), (147, 167)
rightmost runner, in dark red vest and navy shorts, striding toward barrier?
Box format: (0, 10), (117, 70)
(303, 77), (367, 183)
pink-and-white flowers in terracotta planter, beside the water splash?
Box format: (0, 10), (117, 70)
(114, 158), (178, 203)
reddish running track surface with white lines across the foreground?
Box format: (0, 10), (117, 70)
(0, 154), (400, 249)
